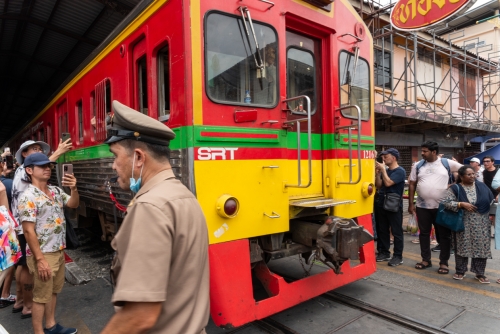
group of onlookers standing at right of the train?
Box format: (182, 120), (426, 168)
(374, 141), (500, 284)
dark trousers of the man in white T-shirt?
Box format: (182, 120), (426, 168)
(417, 207), (451, 266)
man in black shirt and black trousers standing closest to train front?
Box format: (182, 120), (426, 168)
(375, 148), (406, 266)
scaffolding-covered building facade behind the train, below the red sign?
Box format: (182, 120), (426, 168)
(351, 0), (500, 134)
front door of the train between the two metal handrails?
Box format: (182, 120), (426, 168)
(285, 30), (323, 206)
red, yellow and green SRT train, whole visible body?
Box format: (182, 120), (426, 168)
(5, 0), (376, 328)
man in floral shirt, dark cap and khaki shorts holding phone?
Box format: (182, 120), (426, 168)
(18, 153), (80, 334)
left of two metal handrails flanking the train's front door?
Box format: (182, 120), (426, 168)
(281, 95), (312, 188)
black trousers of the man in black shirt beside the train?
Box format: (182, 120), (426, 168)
(375, 206), (404, 257)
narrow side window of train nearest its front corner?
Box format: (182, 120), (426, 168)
(157, 46), (170, 122)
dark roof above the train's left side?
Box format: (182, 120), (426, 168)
(0, 0), (142, 144)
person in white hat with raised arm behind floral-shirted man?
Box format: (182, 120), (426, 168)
(11, 139), (73, 319)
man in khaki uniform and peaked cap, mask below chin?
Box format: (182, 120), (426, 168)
(103, 101), (209, 334)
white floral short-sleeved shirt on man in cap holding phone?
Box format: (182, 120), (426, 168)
(18, 184), (70, 256)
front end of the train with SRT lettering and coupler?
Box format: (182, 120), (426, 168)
(190, 0), (375, 327)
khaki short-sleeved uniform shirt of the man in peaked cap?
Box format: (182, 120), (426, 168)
(111, 169), (209, 334)
